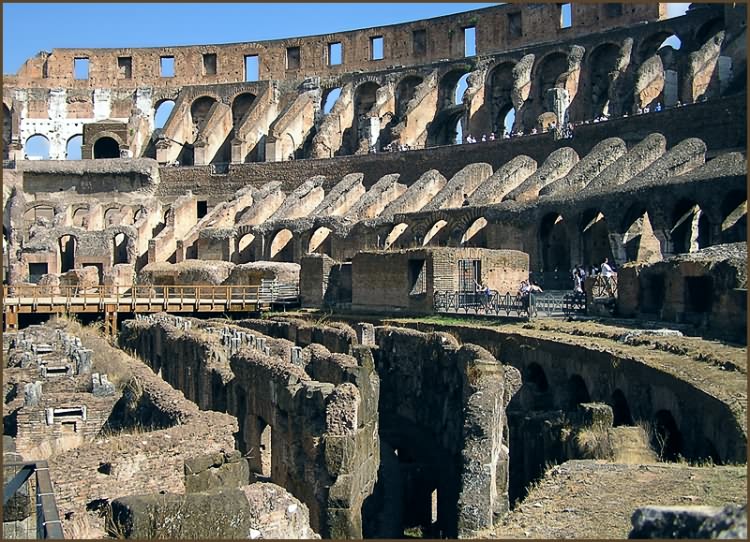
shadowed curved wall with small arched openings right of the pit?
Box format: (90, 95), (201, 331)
(396, 325), (747, 468)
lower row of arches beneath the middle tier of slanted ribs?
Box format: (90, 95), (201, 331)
(236, 190), (747, 271)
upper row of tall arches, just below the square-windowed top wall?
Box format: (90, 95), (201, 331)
(3, 17), (724, 164)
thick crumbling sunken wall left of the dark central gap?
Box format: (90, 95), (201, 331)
(120, 318), (379, 538)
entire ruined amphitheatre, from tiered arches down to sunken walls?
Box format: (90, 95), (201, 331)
(3, 3), (747, 538)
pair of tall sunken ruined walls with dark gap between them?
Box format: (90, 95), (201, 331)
(120, 318), (520, 538)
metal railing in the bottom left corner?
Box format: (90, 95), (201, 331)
(3, 461), (64, 539)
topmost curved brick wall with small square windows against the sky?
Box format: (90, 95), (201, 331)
(6, 4), (666, 89)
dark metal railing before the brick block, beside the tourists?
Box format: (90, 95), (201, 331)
(433, 290), (586, 318)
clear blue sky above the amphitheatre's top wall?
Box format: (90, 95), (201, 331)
(3, 3), (688, 74)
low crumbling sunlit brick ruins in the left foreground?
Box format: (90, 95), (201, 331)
(3, 320), (237, 537)
